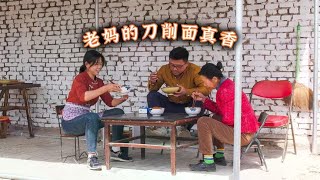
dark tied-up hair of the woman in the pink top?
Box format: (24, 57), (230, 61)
(199, 61), (223, 79)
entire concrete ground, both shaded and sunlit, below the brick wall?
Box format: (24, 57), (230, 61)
(0, 127), (320, 180)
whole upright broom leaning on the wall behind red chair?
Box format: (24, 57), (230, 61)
(284, 23), (313, 110)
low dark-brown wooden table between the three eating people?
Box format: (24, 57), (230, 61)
(102, 113), (199, 175)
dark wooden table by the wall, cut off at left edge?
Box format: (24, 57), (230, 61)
(0, 83), (40, 137)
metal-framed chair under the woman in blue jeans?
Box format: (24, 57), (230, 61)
(56, 105), (88, 163)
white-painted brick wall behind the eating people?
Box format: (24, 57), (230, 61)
(0, 0), (313, 134)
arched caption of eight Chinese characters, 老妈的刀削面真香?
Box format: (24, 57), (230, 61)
(83, 22), (238, 48)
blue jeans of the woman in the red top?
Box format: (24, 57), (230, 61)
(61, 108), (128, 155)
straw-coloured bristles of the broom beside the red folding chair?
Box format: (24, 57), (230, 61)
(284, 83), (313, 111)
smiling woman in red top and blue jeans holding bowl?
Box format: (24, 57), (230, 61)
(61, 50), (132, 170)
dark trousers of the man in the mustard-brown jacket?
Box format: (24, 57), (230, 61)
(147, 91), (204, 130)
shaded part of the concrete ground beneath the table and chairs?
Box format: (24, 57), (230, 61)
(0, 126), (282, 176)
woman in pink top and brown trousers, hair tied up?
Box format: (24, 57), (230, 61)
(190, 62), (258, 172)
